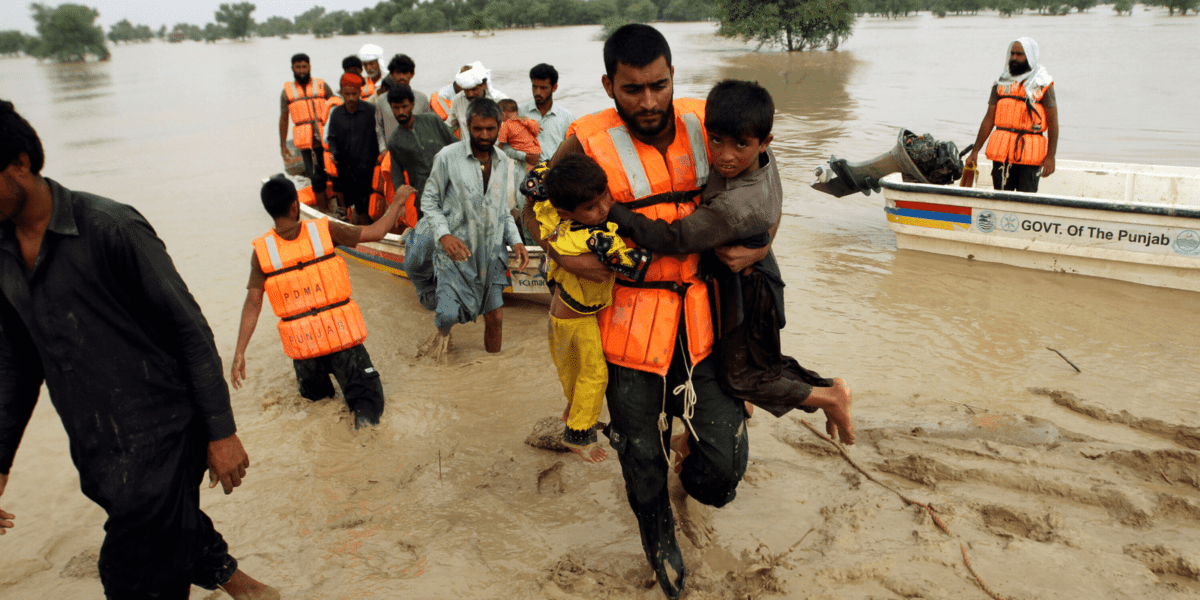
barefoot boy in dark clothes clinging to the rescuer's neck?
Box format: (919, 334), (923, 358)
(608, 80), (854, 444)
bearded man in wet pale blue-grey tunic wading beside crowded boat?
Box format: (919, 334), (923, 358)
(395, 98), (529, 362)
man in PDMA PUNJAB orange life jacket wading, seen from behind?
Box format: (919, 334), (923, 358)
(229, 175), (412, 428)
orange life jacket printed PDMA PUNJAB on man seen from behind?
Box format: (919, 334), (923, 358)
(254, 217), (367, 360)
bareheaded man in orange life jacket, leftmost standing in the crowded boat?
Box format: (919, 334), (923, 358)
(280, 53), (334, 211)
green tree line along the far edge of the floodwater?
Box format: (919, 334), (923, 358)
(0, 0), (1200, 61)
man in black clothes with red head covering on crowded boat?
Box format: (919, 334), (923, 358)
(328, 73), (379, 224)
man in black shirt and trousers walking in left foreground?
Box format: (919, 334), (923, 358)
(0, 102), (280, 600)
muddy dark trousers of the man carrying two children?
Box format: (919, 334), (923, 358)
(607, 336), (750, 598)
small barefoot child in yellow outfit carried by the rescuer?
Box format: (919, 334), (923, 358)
(535, 155), (650, 462)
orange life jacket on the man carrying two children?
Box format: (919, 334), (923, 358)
(566, 98), (713, 376)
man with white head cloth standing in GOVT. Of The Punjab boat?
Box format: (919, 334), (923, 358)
(967, 37), (1058, 192)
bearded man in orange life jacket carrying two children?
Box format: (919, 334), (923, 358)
(523, 24), (769, 598)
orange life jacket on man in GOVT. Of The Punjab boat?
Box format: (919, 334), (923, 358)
(986, 82), (1054, 166)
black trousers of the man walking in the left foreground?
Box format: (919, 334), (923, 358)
(87, 421), (238, 600)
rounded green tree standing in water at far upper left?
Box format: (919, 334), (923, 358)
(25, 2), (109, 62)
